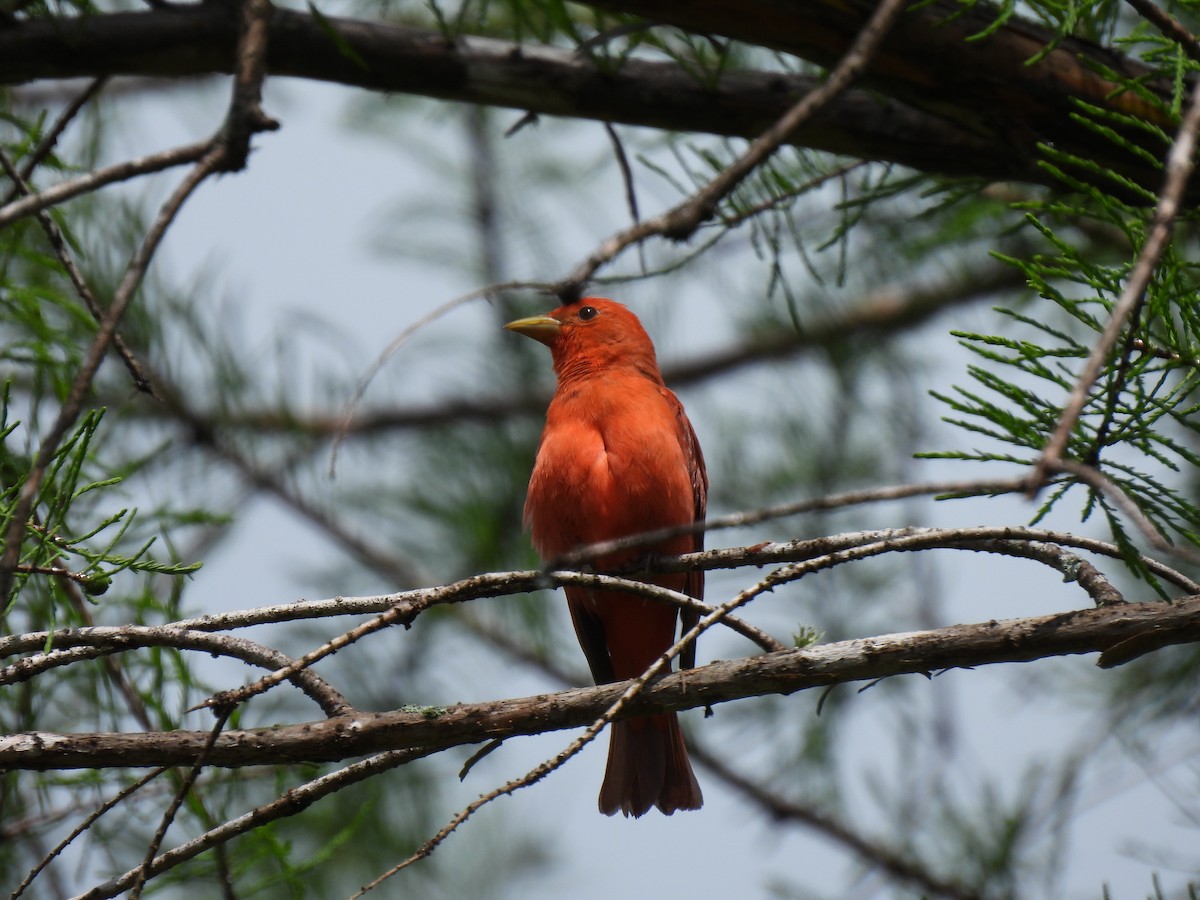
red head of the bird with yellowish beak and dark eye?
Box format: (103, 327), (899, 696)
(504, 296), (661, 380)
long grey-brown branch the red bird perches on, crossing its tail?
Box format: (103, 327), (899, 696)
(9, 596), (1200, 770)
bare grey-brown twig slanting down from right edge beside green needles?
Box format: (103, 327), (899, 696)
(1028, 80), (1200, 494)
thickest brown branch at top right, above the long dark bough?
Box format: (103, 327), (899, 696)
(588, 0), (1171, 196)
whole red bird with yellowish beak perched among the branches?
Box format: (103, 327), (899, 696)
(505, 298), (708, 816)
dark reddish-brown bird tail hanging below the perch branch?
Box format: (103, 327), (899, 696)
(600, 713), (704, 816)
